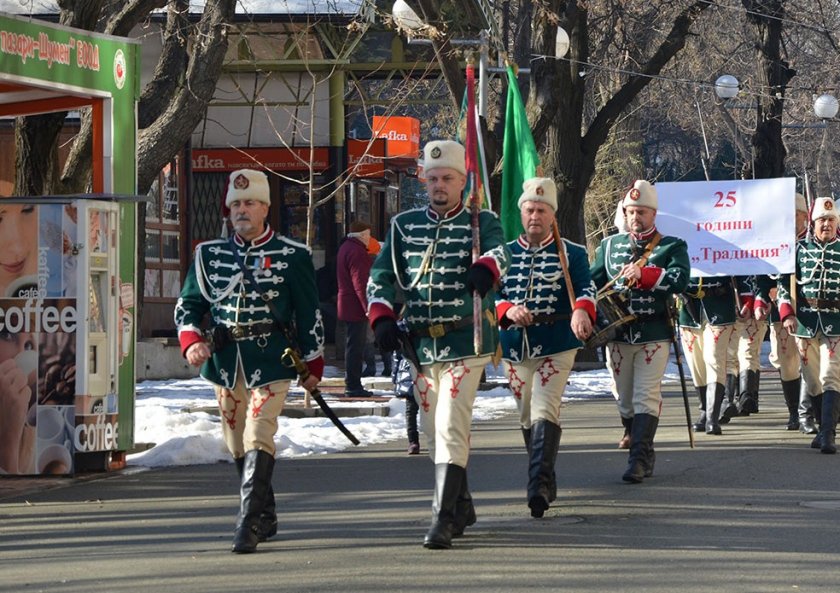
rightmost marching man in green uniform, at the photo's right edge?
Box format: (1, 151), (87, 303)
(779, 198), (840, 453)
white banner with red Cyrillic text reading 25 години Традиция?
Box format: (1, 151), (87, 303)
(656, 177), (796, 277)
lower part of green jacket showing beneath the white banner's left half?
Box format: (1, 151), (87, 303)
(679, 276), (755, 328)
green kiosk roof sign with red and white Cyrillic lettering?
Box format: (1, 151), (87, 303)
(0, 14), (128, 91)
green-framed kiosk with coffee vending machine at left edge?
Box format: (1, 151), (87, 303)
(0, 13), (139, 475)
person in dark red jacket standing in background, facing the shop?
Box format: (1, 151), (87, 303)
(335, 220), (373, 397)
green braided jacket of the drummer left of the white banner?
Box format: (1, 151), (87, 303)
(590, 230), (691, 344)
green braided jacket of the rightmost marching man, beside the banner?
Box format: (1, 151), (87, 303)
(778, 238), (840, 338)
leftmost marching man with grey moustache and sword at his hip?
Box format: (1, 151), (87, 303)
(175, 169), (324, 553)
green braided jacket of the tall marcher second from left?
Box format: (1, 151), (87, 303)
(367, 205), (510, 365)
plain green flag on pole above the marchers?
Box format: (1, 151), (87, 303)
(501, 66), (540, 241)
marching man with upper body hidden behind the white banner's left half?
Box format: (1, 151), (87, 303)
(679, 276), (758, 434)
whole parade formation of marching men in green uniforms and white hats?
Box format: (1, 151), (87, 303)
(175, 140), (840, 553)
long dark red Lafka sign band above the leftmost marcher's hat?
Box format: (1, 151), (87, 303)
(192, 147), (330, 173)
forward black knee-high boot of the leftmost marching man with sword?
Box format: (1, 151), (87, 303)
(231, 449), (276, 554)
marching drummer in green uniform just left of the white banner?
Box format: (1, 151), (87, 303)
(591, 180), (690, 483)
